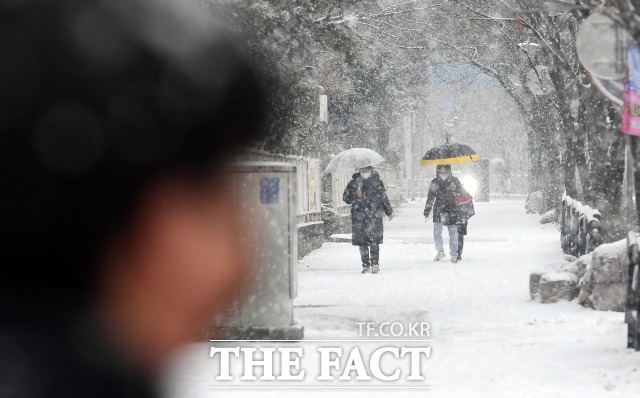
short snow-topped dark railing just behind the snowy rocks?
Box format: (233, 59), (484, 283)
(560, 194), (604, 257)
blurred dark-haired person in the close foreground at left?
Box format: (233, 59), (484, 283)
(0, 0), (266, 398)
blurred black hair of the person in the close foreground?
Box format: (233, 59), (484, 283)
(0, 0), (265, 308)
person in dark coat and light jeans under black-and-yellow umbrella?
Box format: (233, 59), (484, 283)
(423, 165), (465, 263)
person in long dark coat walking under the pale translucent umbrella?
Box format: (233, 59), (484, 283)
(342, 167), (393, 274)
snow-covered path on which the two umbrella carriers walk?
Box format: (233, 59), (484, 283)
(162, 199), (640, 398)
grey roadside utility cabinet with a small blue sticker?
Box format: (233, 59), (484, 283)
(208, 162), (304, 340)
